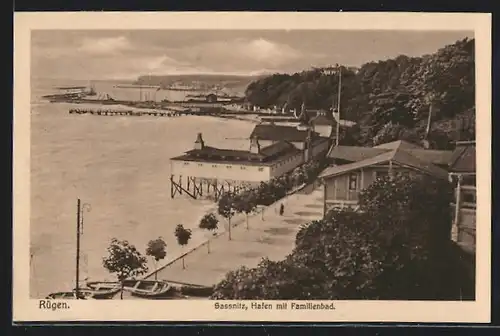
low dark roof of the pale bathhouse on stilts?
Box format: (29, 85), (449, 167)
(171, 141), (300, 165)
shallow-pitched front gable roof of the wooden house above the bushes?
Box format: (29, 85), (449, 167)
(320, 149), (448, 179)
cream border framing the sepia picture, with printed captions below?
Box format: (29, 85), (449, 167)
(13, 12), (491, 322)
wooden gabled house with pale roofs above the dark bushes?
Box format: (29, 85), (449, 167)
(320, 141), (452, 214)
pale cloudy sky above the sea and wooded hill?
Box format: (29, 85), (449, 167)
(31, 30), (473, 80)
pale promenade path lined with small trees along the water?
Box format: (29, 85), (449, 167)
(148, 188), (323, 286)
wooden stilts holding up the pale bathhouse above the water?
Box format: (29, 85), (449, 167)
(170, 175), (255, 201)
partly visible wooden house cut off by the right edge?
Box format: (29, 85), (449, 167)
(449, 141), (476, 253)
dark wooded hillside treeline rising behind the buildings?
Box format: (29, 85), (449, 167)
(245, 38), (475, 149)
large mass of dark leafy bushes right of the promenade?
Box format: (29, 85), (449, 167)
(211, 173), (464, 300)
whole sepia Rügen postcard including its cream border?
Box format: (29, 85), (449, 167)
(13, 12), (491, 323)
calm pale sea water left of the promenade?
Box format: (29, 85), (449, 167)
(30, 80), (254, 298)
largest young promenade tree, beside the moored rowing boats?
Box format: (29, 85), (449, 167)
(102, 238), (148, 299)
